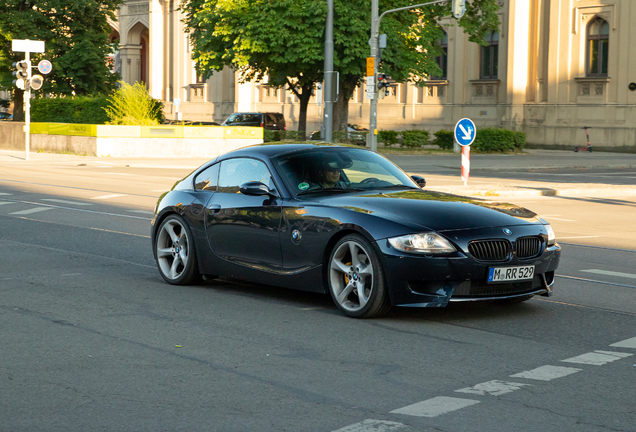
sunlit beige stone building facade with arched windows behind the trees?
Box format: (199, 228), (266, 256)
(111, 0), (636, 151)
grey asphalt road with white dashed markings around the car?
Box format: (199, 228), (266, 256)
(0, 156), (636, 432)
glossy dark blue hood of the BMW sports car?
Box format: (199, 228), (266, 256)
(318, 190), (541, 231)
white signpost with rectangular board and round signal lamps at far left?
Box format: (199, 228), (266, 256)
(11, 39), (53, 160)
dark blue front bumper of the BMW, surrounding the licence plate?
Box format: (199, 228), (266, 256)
(376, 227), (561, 307)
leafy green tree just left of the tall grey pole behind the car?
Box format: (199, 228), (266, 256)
(181, 0), (327, 136)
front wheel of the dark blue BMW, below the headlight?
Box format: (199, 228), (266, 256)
(326, 234), (391, 318)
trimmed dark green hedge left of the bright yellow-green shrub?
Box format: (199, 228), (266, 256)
(31, 96), (108, 124)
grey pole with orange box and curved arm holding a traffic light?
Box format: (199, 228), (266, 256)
(366, 0), (466, 151)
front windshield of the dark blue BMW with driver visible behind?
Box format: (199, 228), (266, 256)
(273, 148), (419, 195)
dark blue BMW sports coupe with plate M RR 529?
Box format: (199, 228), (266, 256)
(152, 144), (561, 318)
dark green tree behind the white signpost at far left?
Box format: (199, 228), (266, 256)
(0, 0), (123, 121)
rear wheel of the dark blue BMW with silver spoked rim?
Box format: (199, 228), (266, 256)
(155, 215), (201, 285)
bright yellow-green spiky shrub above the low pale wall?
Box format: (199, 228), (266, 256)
(104, 81), (162, 126)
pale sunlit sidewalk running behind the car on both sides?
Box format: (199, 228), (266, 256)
(0, 150), (636, 198)
